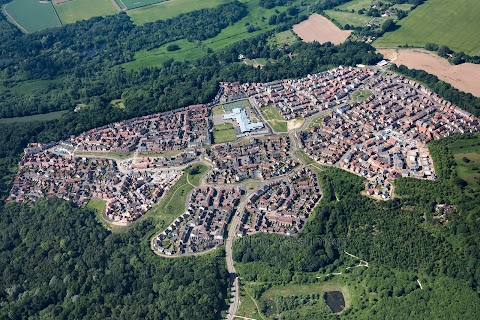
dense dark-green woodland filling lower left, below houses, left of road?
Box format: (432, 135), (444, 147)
(0, 200), (228, 320)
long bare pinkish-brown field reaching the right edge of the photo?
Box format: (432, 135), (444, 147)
(378, 49), (480, 97)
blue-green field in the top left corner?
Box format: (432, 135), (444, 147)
(4, 0), (62, 32)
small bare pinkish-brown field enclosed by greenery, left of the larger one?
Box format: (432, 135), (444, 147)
(293, 13), (352, 44)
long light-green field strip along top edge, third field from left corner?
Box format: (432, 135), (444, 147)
(128, 0), (232, 25)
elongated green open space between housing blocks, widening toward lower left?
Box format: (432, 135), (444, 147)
(148, 164), (208, 226)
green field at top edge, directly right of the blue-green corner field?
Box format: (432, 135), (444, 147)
(55, 0), (118, 24)
